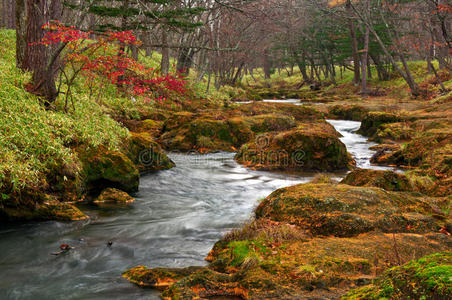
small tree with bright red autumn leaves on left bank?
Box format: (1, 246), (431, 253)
(33, 21), (185, 109)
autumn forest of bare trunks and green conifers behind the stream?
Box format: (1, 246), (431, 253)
(0, 0), (452, 102)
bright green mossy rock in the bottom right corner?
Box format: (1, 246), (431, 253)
(341, 251), (452, 300)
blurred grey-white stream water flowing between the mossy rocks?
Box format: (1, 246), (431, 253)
(0, 121), (388, 300)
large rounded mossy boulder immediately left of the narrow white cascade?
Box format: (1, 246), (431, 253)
(235, 121), (354, 171)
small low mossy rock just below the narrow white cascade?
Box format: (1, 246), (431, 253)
(341, 169), (413, 191)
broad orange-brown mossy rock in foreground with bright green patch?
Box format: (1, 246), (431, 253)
(148, 231), (451, 299)
